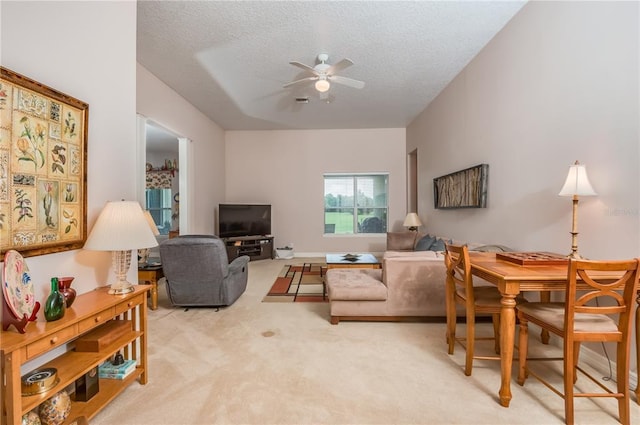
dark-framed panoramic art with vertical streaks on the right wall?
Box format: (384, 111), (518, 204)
(433, 164), (489, 209)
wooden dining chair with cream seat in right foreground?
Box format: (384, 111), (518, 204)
(517, 259), (638, 424)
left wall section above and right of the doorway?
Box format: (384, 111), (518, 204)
(137, 64), (225, 234)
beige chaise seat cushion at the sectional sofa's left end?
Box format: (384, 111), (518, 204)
(325, 268), (387, 301)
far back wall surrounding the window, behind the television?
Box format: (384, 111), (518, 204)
(225, 128), (406, 255)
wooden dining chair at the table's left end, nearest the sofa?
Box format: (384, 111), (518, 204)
(444, 244), (525, 376)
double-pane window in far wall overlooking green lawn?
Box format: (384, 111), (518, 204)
(324, 174), (389, 235)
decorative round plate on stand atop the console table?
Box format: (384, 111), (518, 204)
(2, 250), (36, 319)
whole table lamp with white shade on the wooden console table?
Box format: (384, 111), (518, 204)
(84, 201), (158, 295)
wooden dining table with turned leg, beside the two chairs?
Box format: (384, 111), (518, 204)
(469, 252), (640, 407)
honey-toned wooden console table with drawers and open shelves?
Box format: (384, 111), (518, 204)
(0, 285), (149, 425)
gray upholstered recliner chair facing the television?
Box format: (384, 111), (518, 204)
(160, 235), (249, 307)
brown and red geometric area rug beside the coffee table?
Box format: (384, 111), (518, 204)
(262, 263), (327, 303)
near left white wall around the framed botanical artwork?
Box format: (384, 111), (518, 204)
(0, 1), (137, 303)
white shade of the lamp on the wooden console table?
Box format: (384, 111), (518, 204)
(84, 201), (158, 251)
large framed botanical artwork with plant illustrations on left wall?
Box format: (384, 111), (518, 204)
(0, 67), (89, 257)
